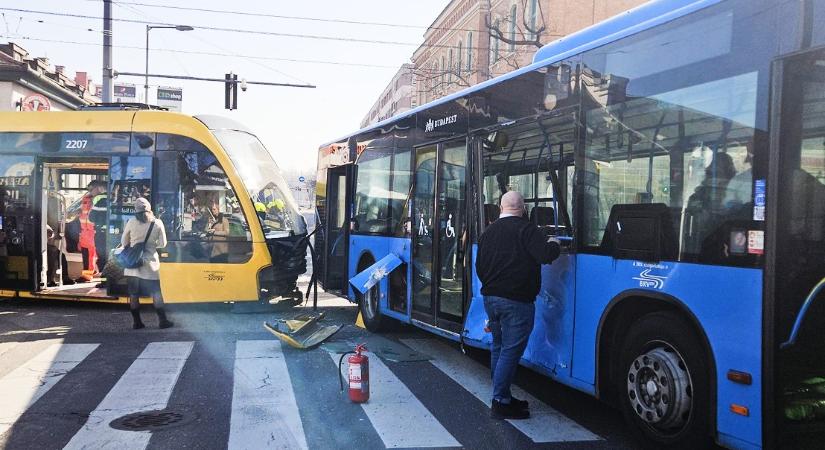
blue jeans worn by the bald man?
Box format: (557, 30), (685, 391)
(484, 296), (536, 403)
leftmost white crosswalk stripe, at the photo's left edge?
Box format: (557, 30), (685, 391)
(0, 344), (98, 435)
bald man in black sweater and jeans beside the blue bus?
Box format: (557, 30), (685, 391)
(476, 191), (561, 419)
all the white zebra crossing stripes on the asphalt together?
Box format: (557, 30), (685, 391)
(0, 339), (601, 450)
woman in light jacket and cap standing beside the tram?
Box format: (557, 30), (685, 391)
(120, 198), (174, 330)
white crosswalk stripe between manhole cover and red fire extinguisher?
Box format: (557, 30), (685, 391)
(229, 340), (307, 450)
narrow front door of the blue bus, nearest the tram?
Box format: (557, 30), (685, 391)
(313, 164), (353, 293)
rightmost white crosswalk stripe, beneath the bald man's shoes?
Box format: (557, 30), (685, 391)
(401, 339), (601, 442)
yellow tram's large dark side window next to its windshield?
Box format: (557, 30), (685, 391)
(156, 151), (251, 263)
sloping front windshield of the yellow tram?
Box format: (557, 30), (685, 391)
(213, 130), (306, 237)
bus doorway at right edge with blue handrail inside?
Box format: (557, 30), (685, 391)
(768, 44), (825, 448)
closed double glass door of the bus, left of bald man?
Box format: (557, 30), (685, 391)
(412, 139), (468, 332)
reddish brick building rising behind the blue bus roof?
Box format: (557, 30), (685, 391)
(412, 0), (646, 105)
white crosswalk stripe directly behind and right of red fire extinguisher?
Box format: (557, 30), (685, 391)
(330, 353), (461, 448)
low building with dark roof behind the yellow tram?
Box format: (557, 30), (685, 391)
(0, 42), (100, 111)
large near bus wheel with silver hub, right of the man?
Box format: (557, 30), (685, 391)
(614, 312), (711, 448)
